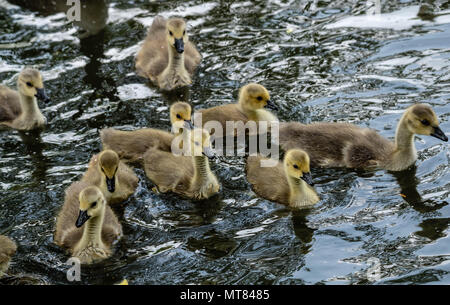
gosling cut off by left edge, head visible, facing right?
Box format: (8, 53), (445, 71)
(0, 68), (50, 131)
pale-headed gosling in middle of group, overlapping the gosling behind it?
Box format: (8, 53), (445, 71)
(144, 129), (220, 199)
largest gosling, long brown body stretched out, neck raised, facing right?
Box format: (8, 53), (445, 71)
(279, 104), (448, 171)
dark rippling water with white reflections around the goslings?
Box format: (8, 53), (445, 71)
(0, 0), (450, 284)
